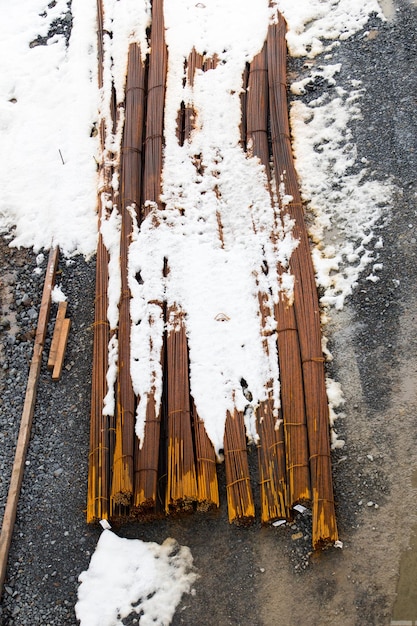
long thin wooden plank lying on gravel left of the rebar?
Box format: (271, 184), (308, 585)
(0, 247), (59, 597)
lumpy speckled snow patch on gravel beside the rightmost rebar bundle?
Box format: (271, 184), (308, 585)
(291, 88), (392, 309)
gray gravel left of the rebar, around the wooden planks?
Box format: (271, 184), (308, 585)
(0, 241), (98, 626)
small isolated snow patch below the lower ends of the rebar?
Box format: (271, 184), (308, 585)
(75, 530), (197, 626)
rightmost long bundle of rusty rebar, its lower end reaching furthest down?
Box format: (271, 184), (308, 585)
(267, 14), (338, 548)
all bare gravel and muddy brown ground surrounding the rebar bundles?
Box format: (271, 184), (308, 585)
(0, 0), (417, 626)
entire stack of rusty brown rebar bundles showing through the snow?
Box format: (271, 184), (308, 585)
(87, 0), (337, 548)
